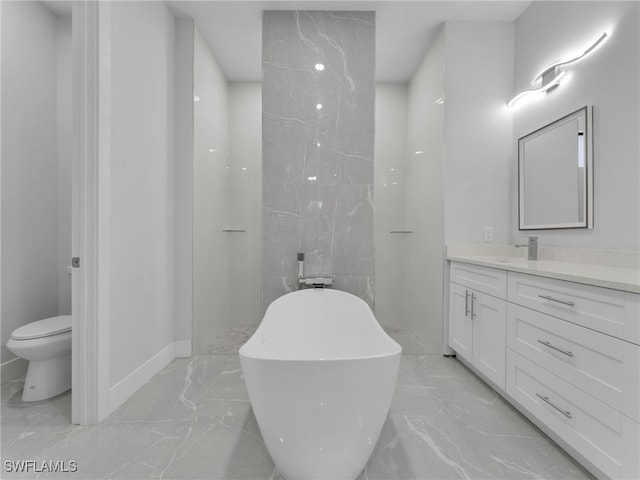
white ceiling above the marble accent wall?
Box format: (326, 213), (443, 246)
(45, 0), (531, 83)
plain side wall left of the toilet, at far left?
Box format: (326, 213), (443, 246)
(1, 2), (60, 372)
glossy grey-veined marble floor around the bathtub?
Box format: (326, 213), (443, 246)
(0, 355), (590, 480)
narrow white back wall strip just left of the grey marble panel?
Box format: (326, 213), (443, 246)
(227, 82), (262, 327)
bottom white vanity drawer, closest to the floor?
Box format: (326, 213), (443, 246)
(507, 349), (640, 478)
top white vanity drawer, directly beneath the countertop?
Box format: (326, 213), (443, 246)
(508, 272), (640, 345)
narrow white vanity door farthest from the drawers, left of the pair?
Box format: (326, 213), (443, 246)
(449, 283), (473, 362)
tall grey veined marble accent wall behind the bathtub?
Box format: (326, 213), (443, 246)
(262, 11), (375, 310)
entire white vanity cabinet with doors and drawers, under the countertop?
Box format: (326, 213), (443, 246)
(449, 261), (640, 479)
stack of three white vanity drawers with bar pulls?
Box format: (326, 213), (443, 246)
(506, 272), (640, 479)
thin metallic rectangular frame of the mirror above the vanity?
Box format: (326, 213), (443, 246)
(518, 106), (593, 230)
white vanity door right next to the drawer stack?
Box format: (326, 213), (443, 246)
(471, 291), (507, 390)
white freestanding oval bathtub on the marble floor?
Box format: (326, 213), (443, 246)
(239, 289), (402, 480)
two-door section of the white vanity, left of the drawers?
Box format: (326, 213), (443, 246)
(449, 263), (507, 389)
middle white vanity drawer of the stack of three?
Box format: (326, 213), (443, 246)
(507, 303), (640, 421)
